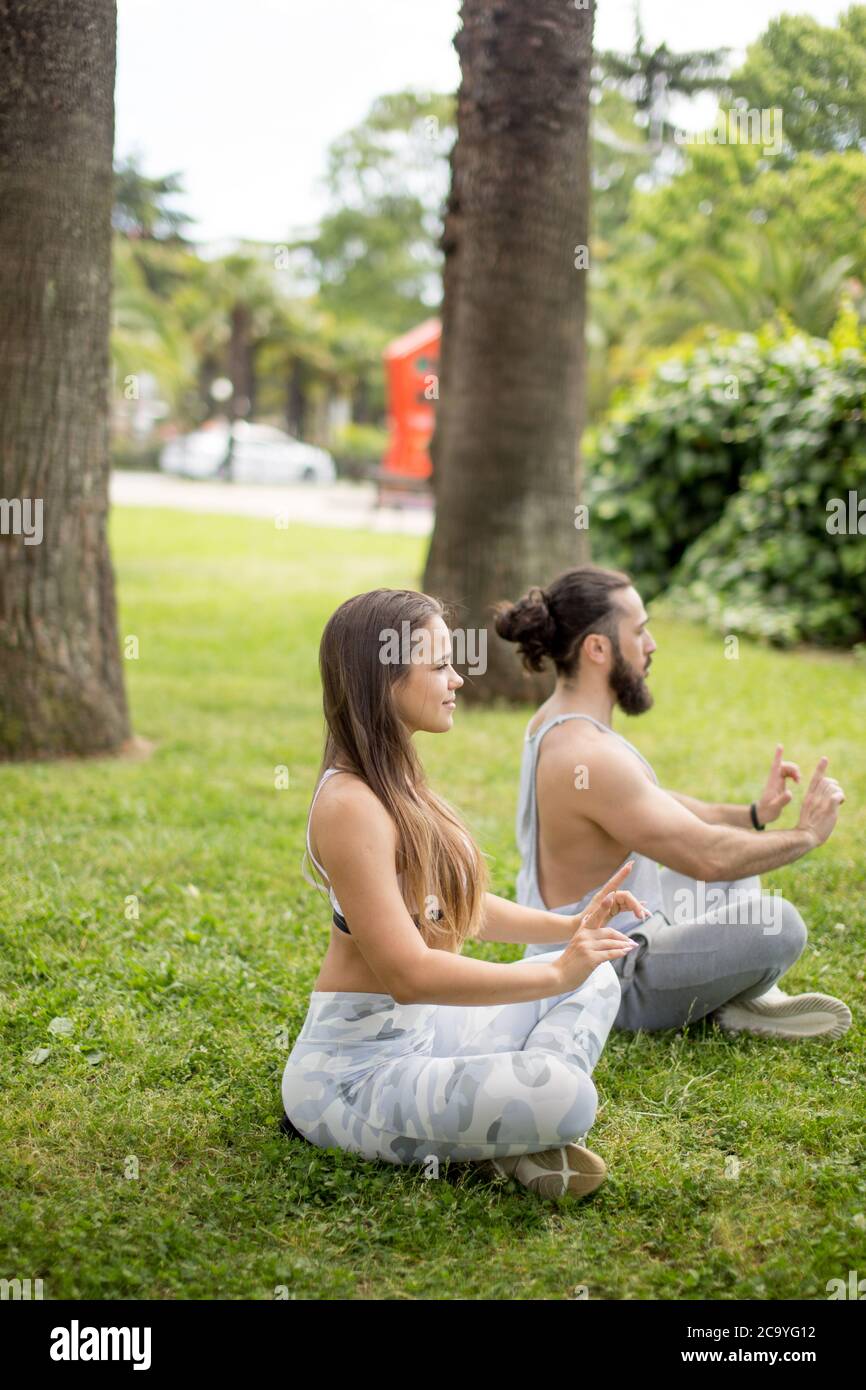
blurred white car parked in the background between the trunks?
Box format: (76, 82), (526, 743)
(160, 420), (336, 484)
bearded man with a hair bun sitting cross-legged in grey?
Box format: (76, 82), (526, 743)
(495, 564), (851, 1038)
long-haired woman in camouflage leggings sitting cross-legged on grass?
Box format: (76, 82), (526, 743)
(282, 589), (644, 1197)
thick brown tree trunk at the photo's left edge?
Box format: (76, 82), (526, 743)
(0, 0), (129, 759)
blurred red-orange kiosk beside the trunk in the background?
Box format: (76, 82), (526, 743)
(379, 318), (442, 505)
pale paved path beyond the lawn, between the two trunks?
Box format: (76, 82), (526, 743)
(110, 470), (432, 535)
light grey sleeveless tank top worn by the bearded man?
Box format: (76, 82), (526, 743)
(517, 714), (663, 958)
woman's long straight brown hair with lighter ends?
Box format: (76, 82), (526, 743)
(310, 589), (488, 951)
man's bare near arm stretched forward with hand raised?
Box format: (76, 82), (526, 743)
(580, 748), (844, 883)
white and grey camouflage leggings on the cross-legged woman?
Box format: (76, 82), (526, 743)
(282, 949), (620, 1163)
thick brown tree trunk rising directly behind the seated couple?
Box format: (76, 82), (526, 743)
(424, 0), (594, 702)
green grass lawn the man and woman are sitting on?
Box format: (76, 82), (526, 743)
(0, 510), (866, 1300)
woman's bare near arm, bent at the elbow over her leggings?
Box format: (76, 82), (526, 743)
(313, 777), (616, 1004)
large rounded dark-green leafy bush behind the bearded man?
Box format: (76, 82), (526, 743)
(589, 322), (866, 646)
